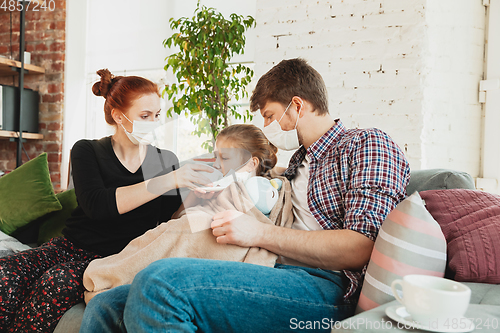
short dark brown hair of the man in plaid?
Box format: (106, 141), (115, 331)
(250, 58), (328, 115)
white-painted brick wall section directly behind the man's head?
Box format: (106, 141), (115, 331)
(255, 0), (425, 168)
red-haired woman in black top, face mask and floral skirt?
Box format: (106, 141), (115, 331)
(0, 69), (212, 332)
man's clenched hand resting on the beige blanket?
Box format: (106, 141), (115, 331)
(211, 210), (268, 247)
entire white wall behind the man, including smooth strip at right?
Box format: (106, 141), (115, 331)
(255, 0), (484, 176)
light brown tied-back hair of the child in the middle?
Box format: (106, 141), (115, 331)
(217, 124), (278, 176)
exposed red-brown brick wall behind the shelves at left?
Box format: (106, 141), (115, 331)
(0, 0), (66, 189)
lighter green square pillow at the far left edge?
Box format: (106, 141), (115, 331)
(0, 153), (62, 235)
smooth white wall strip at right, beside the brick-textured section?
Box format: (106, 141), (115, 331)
(421, 0), (485, 177)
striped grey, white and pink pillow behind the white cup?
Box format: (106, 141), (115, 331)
(356, 192), (446, 313)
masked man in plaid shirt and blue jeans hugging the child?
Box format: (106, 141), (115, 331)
(84, 59), (410, 332)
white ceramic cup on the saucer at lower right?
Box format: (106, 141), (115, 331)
(391, 274), (471, 325)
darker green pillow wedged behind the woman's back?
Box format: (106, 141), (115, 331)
(38, 189), (78, 245)
